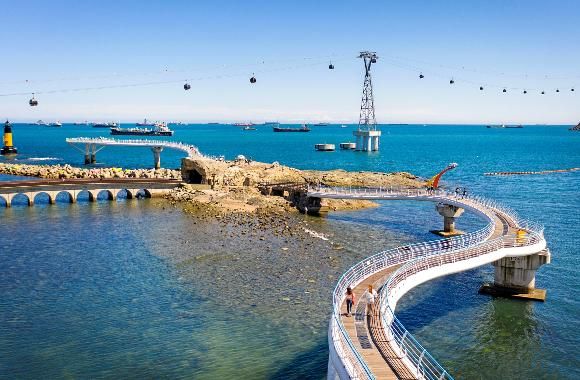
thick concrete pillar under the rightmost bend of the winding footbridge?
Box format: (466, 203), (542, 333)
(480, 249), (550, 301)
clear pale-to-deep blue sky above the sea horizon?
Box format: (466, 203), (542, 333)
(0, 0), (580, 124)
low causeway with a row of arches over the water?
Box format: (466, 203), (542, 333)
(0, 178), (181, 207)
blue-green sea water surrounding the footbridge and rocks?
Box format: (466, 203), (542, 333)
(0, 125), (580, 379)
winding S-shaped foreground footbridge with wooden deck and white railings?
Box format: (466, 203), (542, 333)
(308, 188), (550, 379)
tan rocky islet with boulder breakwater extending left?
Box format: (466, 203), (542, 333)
(0, 157), (424, 218)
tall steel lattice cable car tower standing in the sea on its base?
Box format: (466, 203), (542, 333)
(352, 51), (381, 152)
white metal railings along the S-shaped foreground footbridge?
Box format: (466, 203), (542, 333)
(320, 186), (543, 379)
